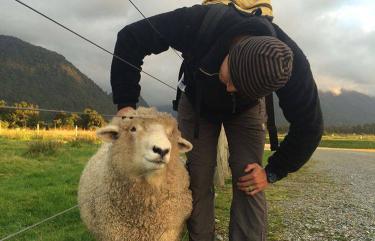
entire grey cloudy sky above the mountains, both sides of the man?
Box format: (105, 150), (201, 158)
(0, 0), (375, 105)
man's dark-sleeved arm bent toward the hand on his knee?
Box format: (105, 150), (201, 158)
(265, 25), (323, 182)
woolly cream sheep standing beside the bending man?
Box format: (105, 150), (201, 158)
(78, 107), (192, 241)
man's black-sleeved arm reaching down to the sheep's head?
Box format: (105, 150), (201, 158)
(111, 5), (206, 109)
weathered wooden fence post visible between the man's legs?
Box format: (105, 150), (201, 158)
(215, 126), (231, 187)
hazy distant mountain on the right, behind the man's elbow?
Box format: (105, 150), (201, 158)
(275, 89), (375, 126)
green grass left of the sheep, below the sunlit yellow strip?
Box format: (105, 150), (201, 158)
(0, 138), (97, 241)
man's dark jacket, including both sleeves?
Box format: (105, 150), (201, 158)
(111, 5), (323, 181)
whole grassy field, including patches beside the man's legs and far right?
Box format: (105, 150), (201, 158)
(0, 130), (375, 241)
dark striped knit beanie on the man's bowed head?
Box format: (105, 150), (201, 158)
(229, 36), (293, 99)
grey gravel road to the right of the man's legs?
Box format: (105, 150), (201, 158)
(269, 149), (375, 241)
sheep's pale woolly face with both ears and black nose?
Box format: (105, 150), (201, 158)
(98, 109), (192, 175)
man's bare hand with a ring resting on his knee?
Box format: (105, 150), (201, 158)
(237, 163), (268, 196)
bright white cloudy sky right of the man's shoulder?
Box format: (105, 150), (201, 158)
(274, 0), (375, 98)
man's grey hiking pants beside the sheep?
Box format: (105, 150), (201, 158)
(178, 95), (267, 241)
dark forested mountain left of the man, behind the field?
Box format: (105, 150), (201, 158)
(0, 35), (147, 114)
